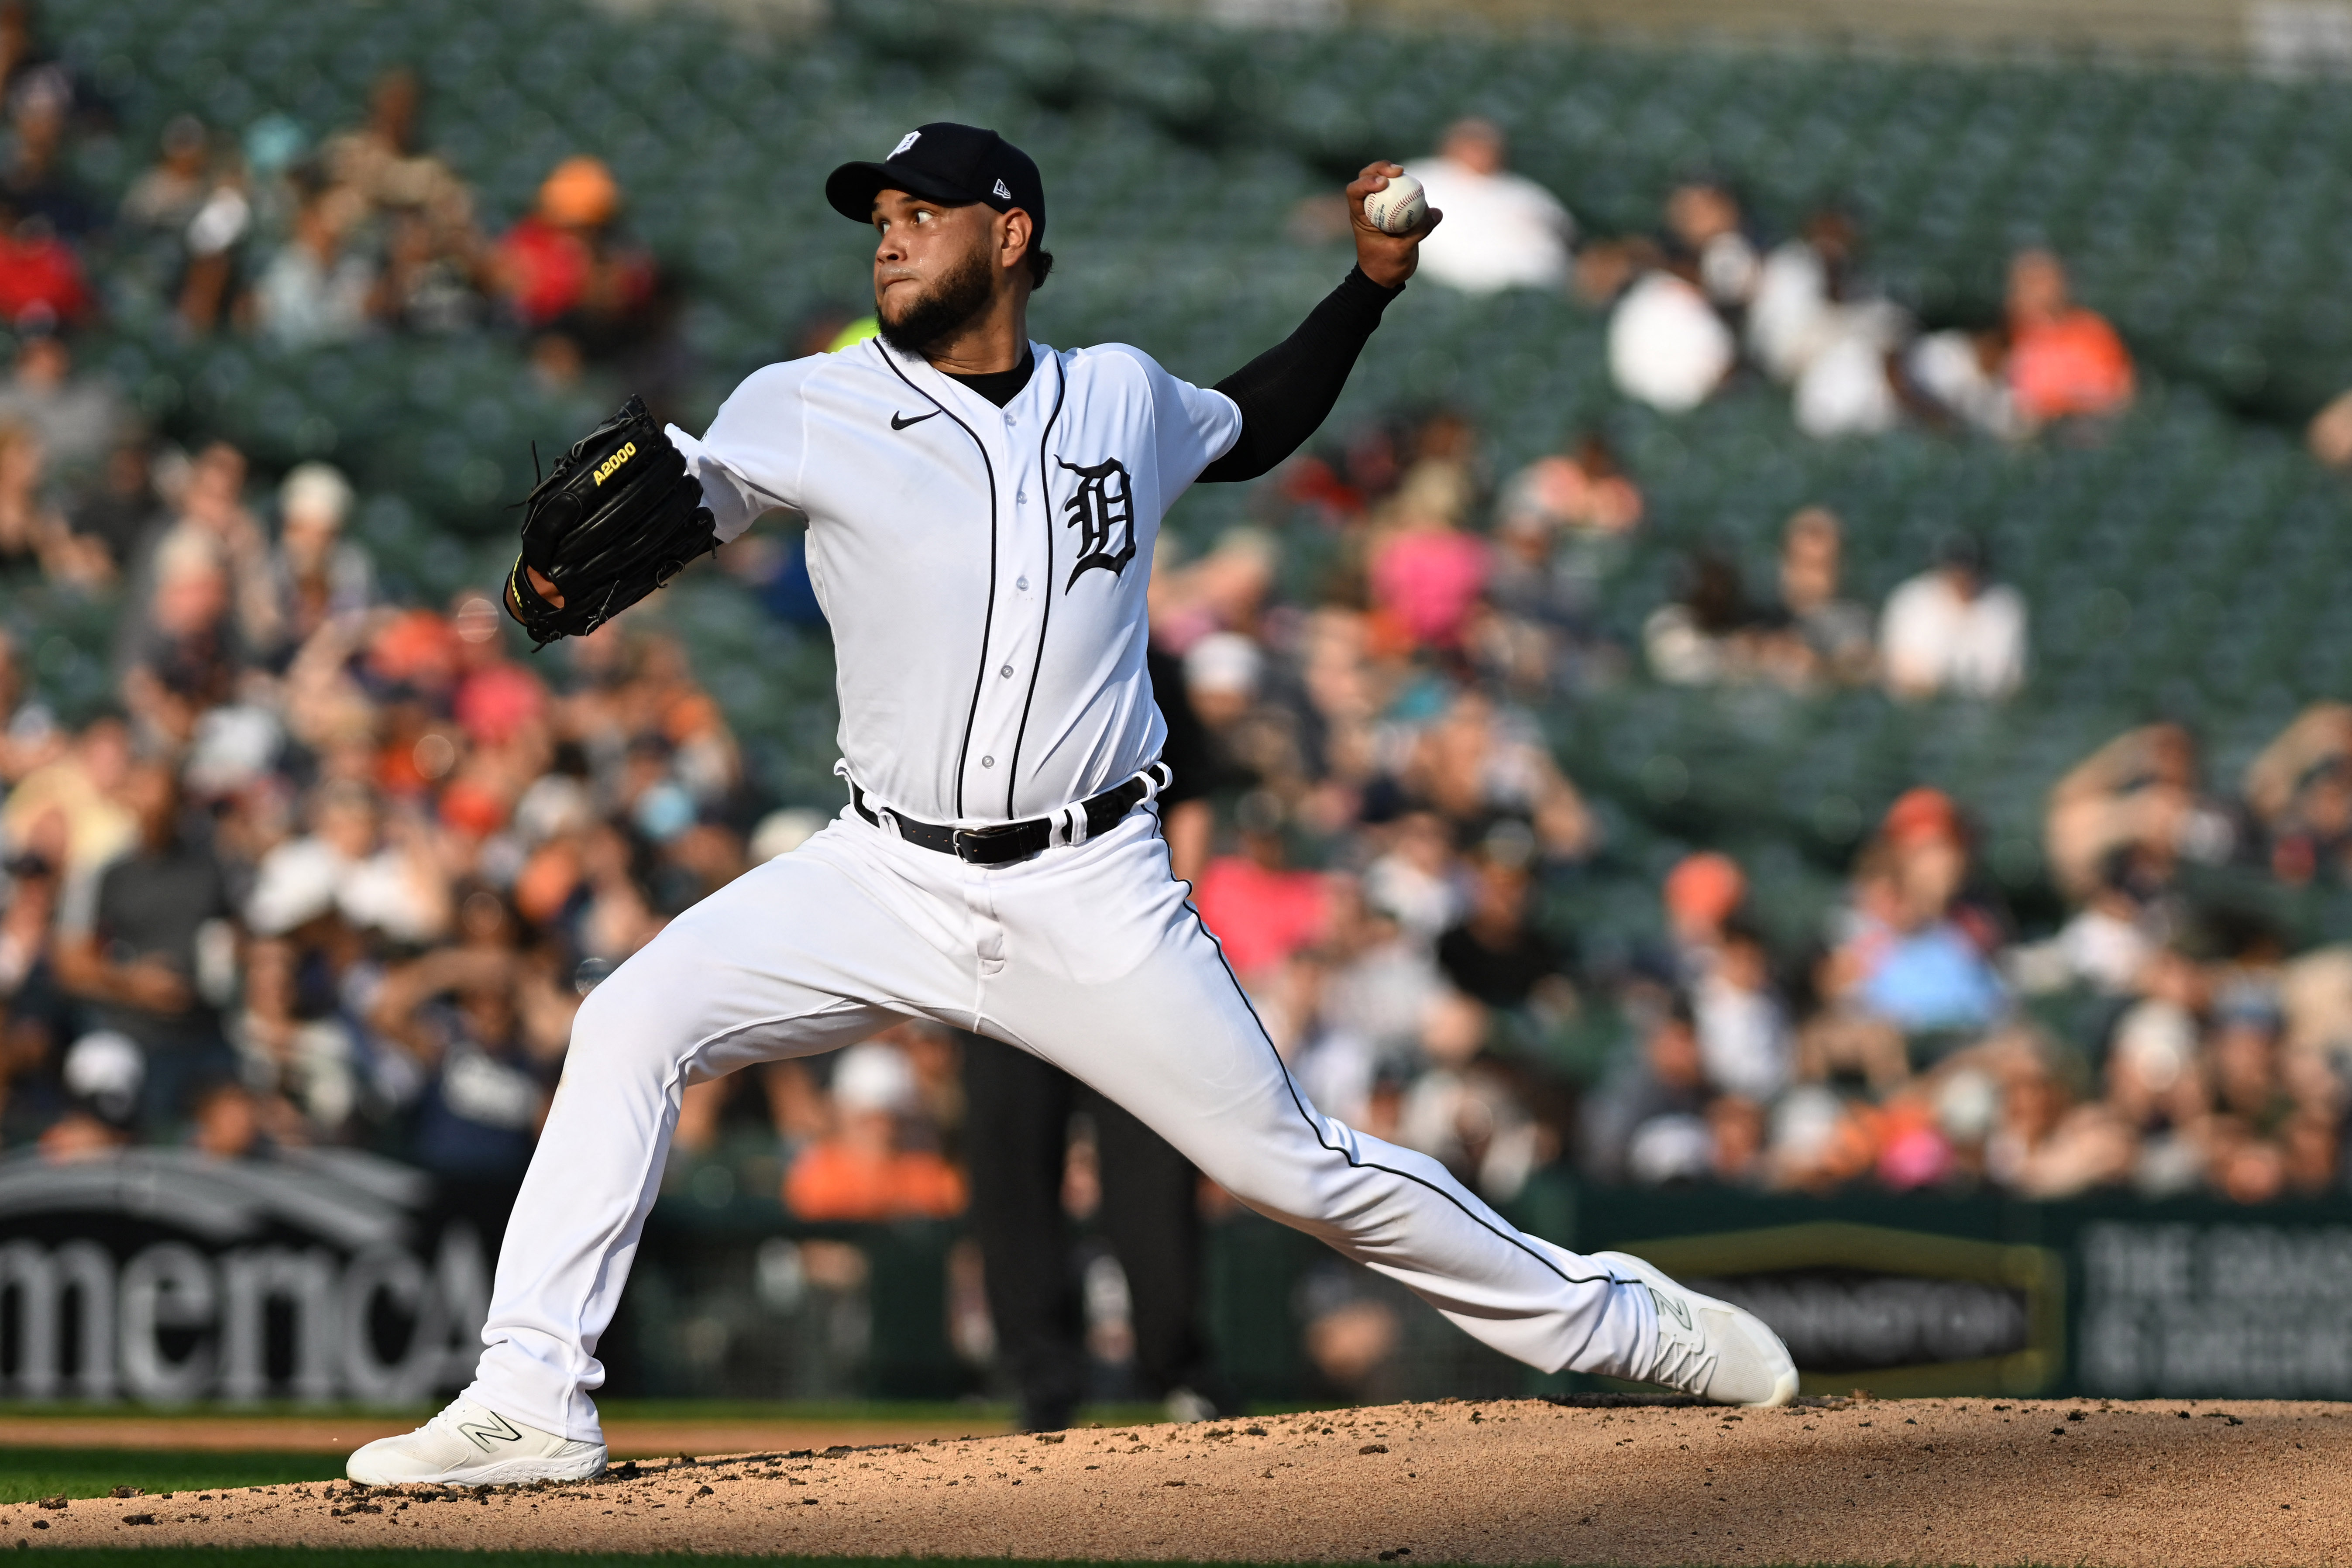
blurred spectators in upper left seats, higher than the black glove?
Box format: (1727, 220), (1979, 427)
(0, 20), (671, 390)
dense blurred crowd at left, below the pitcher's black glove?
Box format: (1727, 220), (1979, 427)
(0, 444), (750, 1178)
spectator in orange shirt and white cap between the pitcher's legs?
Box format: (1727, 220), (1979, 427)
(783, 1039), (964, 1220)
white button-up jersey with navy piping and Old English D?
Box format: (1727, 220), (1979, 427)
(671, 338), (1242, 825)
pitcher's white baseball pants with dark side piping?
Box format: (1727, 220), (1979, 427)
(468, 811), (1656, 1441)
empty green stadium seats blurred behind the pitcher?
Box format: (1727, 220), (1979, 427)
(24, 0), (2352, 957)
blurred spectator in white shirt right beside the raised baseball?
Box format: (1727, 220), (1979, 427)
(1404, 120), (1576, 294)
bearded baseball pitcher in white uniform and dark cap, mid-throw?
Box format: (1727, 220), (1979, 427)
(351, 124), (1797, 1486)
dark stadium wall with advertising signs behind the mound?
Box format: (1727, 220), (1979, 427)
(0, 1152), (2352, 1403)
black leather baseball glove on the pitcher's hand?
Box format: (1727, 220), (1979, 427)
(505, 395), (720, 646)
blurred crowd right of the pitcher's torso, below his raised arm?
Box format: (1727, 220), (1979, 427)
(1155, 395), (2352, 1201)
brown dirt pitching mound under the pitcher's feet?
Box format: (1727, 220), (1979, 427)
(0, 1399), (2352, 1566)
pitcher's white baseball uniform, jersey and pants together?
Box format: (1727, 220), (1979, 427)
(449, 322), (1684, 1441)
